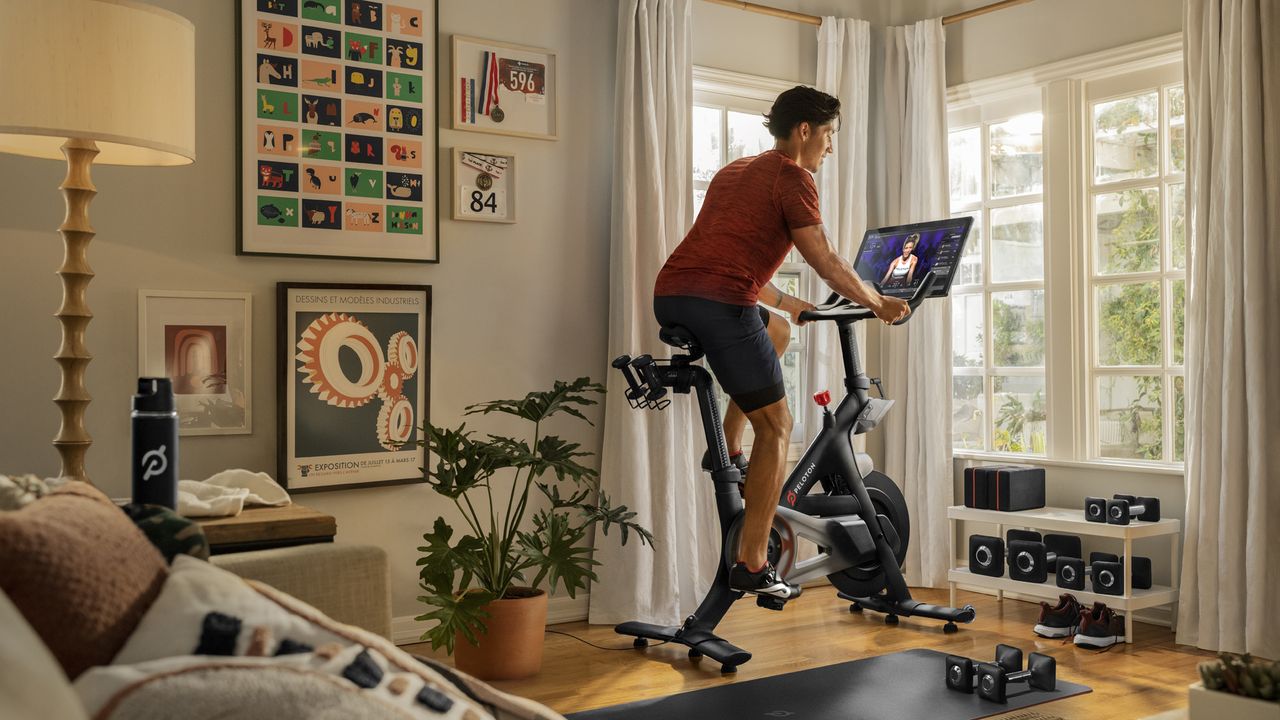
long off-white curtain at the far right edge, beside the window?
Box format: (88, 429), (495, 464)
(1178, 0), (1280, 659)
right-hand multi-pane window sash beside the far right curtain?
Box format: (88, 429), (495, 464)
(1088, 85), (1187, 462)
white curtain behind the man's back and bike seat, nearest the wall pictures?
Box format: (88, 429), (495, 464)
(590, 0), (721, 624)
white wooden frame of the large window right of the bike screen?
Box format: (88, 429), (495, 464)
(947, 33), (1189, 475)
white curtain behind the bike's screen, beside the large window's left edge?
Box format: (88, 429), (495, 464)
(879, 19), (954, 587)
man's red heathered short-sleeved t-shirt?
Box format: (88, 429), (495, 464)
(653, 150), (822, 305)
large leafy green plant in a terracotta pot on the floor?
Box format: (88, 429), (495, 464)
(416, 378), (653, 679)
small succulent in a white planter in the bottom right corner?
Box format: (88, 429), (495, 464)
(1190, 652), (1280, 720)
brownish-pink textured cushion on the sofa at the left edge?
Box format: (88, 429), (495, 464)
(0, 482), (166, 679)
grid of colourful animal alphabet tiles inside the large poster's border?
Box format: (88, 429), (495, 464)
(252, 0), (435, 236)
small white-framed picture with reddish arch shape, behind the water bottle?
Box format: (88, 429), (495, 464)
(138, 290), (253, 436)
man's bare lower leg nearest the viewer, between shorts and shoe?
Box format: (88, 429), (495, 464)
(736, 397), (792, 571)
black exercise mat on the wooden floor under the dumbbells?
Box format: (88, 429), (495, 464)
(568, 650), (1092, 720)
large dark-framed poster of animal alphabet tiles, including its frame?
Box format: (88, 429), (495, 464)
(237, 0), (440, 263)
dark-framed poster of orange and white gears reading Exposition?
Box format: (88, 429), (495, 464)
(276, 283), (431, 492)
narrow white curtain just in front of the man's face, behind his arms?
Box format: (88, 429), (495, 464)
(814, 17), (872, 450)
